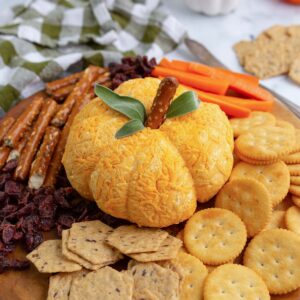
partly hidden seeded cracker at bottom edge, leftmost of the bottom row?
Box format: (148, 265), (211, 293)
(47, 270), (88, 300)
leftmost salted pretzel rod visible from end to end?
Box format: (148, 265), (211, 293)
(4, 96), (44, 148)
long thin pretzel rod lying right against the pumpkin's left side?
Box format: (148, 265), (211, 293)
(43, 91), (94, 187)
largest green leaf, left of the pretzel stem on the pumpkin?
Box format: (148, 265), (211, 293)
(95, 84), (146, 123)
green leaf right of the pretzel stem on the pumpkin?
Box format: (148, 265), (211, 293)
(167, 91), (200, 119)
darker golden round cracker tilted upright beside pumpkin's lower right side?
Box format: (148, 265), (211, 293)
(215, 178), (272, 237)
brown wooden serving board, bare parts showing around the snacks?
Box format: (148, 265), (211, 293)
(0, 94), (300, 300)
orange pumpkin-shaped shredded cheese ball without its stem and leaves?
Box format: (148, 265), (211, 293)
(63, 77), (233, 227)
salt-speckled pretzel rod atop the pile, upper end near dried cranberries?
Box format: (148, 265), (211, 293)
(51, 66), (104, 127)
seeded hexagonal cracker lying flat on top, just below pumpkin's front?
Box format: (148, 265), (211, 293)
(107, 225), (168, 254)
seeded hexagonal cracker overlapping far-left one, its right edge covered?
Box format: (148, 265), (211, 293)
(68, 221), (122, 265)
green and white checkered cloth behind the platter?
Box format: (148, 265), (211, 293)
(0, 0), (185, 115)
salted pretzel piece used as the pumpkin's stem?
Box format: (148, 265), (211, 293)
(146, 77), (178, 129)
